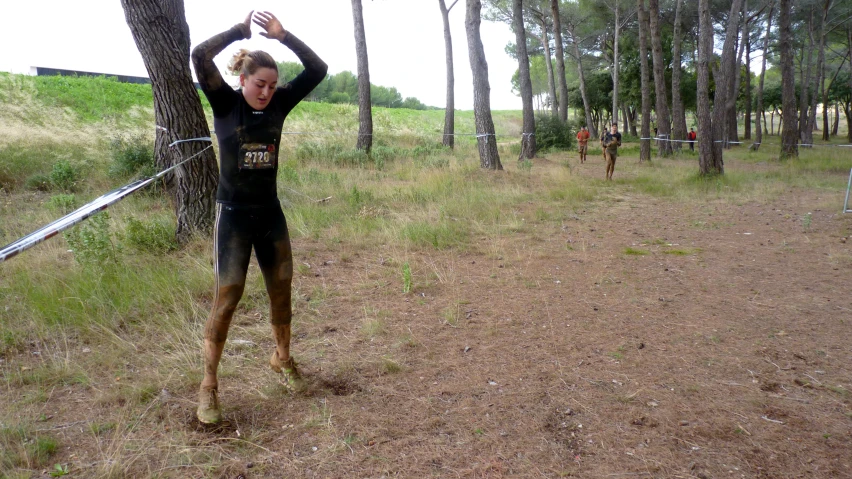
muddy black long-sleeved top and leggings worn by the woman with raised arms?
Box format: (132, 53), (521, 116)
(192, 24), (328, 358)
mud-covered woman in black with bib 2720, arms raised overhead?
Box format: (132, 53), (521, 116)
(192, 12), (328, 424)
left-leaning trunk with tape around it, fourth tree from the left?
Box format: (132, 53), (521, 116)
(464, 0), (503, 170)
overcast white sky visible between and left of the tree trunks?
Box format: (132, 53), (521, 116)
(0, 0), (521, 110)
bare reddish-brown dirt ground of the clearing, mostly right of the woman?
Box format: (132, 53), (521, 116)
(1, 155), (852, 478)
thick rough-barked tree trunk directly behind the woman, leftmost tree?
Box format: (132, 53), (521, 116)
(121, 0), (219, 244)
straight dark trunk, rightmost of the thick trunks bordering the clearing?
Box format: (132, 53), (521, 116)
(778, 0), (799, 159)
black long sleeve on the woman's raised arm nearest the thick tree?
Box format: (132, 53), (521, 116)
(192, 23), (248, 117)
